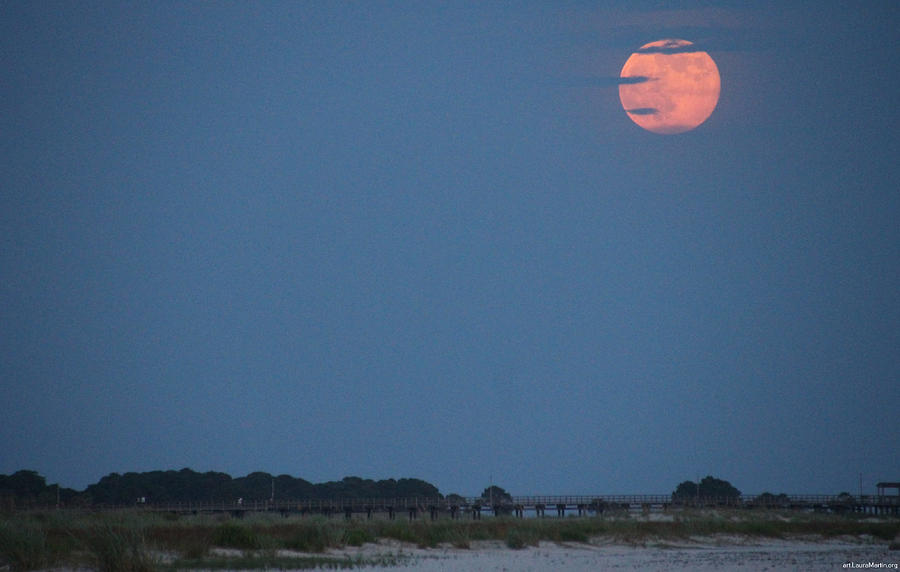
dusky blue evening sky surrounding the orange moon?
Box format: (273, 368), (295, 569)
(0, 2), (900, 495)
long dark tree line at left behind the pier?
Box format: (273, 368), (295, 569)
(0, 468), (442, 508)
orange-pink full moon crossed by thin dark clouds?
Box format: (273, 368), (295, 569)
(619, 39), (721, 135)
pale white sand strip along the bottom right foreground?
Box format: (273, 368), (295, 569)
(332, 538), (900, 572)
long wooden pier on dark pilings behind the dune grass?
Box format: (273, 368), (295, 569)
(91, 495), (900, 520)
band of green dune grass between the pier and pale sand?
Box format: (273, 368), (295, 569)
(0, 510), (900, 572)
